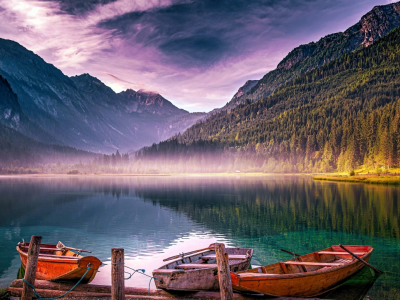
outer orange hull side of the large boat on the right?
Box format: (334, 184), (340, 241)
(231, 246), (372, 297)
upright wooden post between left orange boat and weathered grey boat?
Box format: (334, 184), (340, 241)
(111, 248), (125, 300)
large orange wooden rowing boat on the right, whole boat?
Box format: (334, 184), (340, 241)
(231, 246), (374, 297)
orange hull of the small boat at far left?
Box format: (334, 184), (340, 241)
(17, 245), (101, 283)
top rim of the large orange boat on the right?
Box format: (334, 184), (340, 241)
(236, 245), (374, 282)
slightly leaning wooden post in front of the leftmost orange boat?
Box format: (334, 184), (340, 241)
(21, 235), (42, 300)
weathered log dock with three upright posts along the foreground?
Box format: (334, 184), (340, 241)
(7, 236), (332, 300)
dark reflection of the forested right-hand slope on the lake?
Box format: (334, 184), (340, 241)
(135, 178), (400, 238)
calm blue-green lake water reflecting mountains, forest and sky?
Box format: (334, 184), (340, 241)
(0, 176), (400, 299)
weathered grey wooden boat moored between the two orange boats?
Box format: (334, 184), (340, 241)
(153, 244), (253, 291)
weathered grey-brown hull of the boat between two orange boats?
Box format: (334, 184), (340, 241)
(153, 248), (253, 291)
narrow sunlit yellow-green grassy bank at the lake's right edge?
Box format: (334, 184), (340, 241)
(313, 175), (400, 185)
